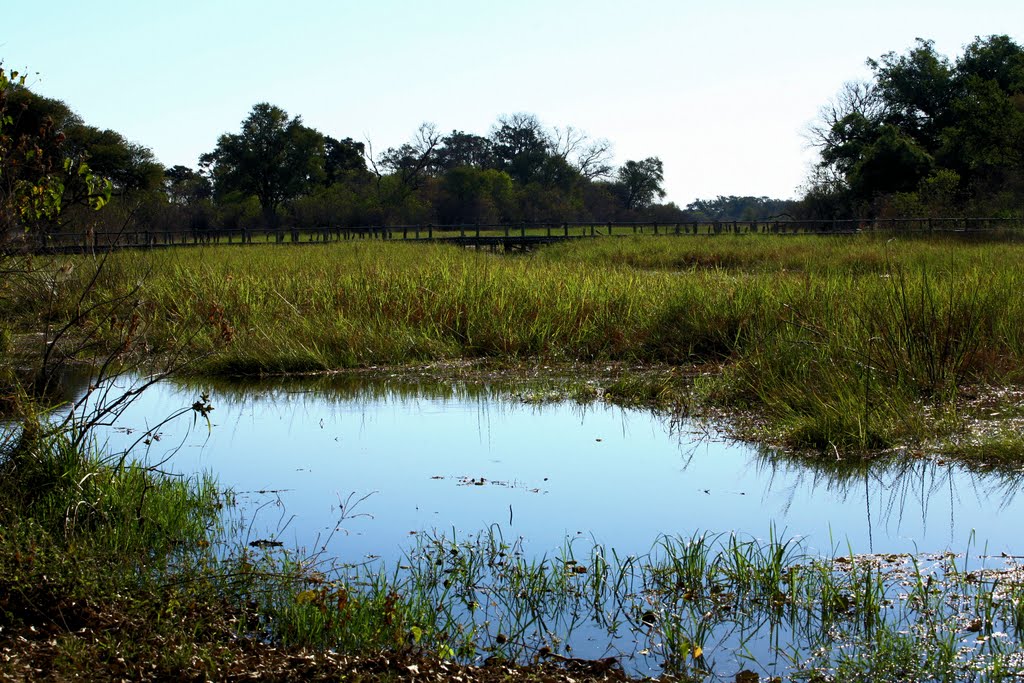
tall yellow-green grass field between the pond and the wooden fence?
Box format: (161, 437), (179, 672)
(8, 236), (1024, 452)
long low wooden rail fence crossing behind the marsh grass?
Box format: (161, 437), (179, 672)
(12, 217), (1024, 253)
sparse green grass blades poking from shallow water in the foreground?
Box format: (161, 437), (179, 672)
(234, 529), (1024, 681)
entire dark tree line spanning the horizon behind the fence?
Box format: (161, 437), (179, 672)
(0, 36), (1024, 242)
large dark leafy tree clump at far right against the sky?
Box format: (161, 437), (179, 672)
(808, 36), (1024, 214)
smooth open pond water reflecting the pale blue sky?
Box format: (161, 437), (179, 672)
(79, 376), (1021, 561)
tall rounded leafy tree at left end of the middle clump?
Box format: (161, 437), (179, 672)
(200, 102), (324, 224)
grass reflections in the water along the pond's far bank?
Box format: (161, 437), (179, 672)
(172, 369), (1024, 540)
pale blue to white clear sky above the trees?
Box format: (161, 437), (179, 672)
(0, 0), (1024, 207)
